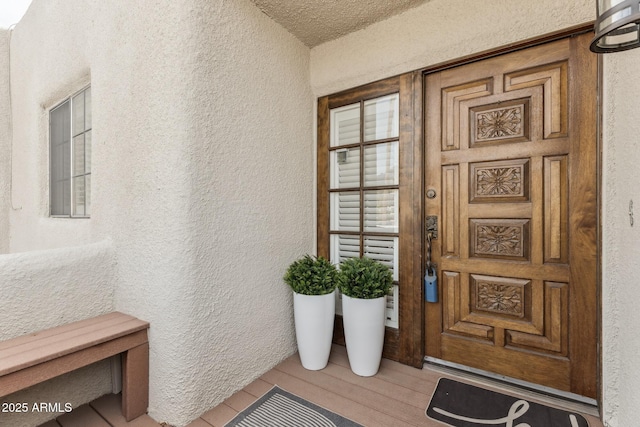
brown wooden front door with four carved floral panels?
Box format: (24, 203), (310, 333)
(425, 35), (598, 398)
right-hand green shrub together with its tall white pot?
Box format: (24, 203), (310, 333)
(338, 257), (393, 377)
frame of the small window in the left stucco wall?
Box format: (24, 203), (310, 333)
(48, 84), (93, 219)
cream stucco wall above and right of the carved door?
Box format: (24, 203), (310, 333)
(311, 0), (640, 427)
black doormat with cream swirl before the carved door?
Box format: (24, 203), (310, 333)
(426, 378), (589, 427)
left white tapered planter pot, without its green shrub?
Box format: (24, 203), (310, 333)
(293, 291), (336, 371)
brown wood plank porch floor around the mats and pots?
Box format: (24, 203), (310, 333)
(41, 346), (602, 427)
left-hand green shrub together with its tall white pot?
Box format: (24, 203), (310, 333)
(284, 255), (338, 371)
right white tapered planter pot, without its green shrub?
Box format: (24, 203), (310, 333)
(342, 295), (387, 377)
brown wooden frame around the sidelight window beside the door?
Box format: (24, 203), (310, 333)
(316, 71), (424, 366)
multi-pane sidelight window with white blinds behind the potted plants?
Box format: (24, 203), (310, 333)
(329, 93), (400, 328)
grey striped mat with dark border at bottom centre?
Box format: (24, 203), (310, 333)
(225, 386), (363, 427)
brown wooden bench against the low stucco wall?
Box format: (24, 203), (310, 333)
(0, 312), (149, 421)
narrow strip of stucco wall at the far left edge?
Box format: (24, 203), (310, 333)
(0, 28), (11, 254)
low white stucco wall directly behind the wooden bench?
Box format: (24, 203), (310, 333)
(0, 240), (116, 340)
